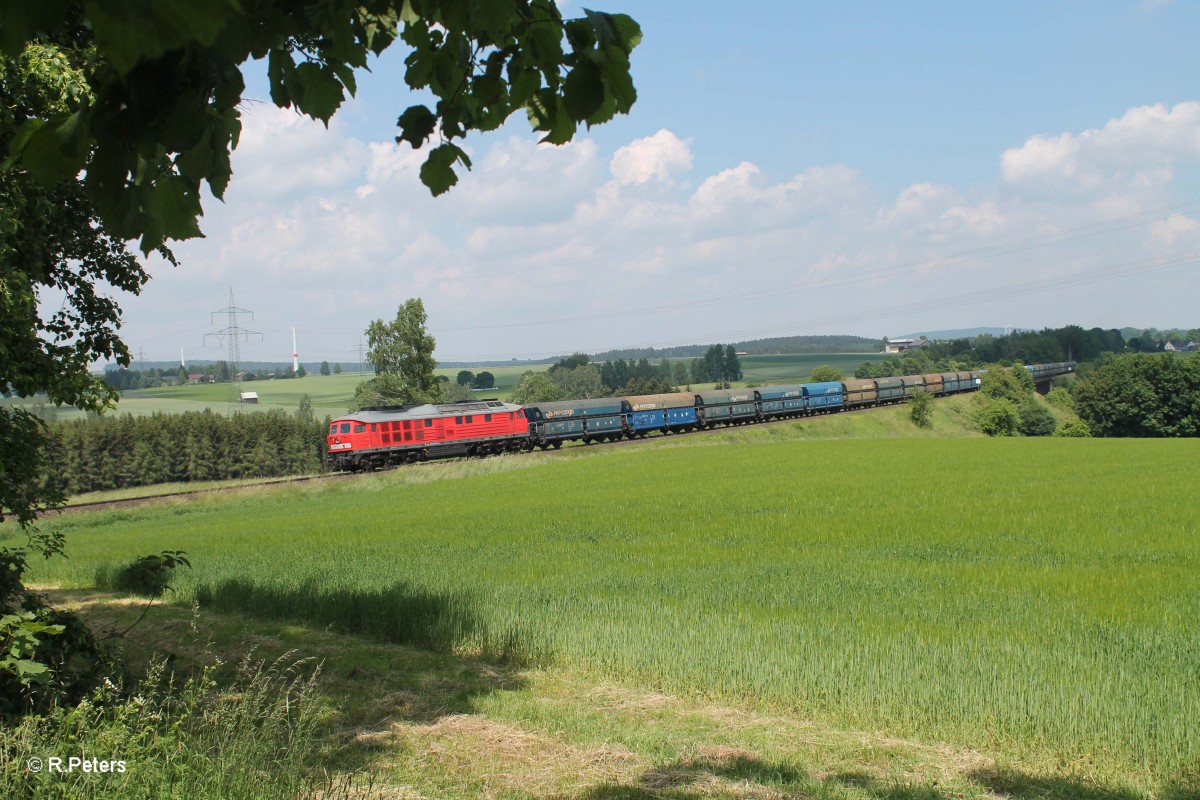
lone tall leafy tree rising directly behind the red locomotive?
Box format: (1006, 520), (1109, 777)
(354, 297), (445, 408)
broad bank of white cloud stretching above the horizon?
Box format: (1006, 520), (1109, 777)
(117, 103), (1200, 362)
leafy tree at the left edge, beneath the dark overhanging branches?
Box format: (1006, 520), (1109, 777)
(0, 45), (150, 525)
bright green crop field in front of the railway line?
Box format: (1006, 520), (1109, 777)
(21, 431), (1200, 799)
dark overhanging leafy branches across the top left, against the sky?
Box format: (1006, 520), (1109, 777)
(0, 0), (641, 253)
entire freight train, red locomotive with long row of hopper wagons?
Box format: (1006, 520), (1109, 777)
(325, 361), (1075, 470)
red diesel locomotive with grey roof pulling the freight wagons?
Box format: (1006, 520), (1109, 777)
(326, 401), (529, 470)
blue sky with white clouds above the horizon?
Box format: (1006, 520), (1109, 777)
(115, 0), (1200, 365)
